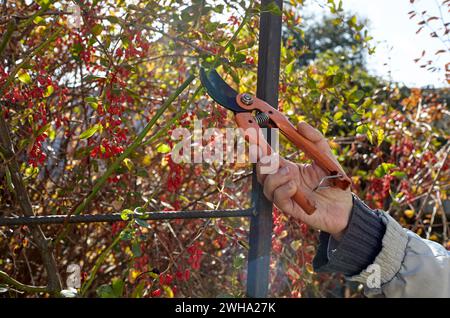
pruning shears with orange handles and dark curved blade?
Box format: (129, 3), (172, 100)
(200, 68), (351, 215)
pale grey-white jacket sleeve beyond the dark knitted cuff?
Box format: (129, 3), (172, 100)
(348, 213), (450, 298)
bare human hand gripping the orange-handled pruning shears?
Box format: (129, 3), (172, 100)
(257, 122), (353, 240)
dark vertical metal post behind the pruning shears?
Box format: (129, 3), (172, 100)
(247, 0), (283, 298)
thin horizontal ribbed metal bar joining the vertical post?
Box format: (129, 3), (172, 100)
(0, 207), (256, 226)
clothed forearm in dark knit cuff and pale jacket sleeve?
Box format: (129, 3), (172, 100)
(314, 197), (450, 297)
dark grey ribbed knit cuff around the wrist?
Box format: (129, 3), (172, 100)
(313, 195), (386, 276)
